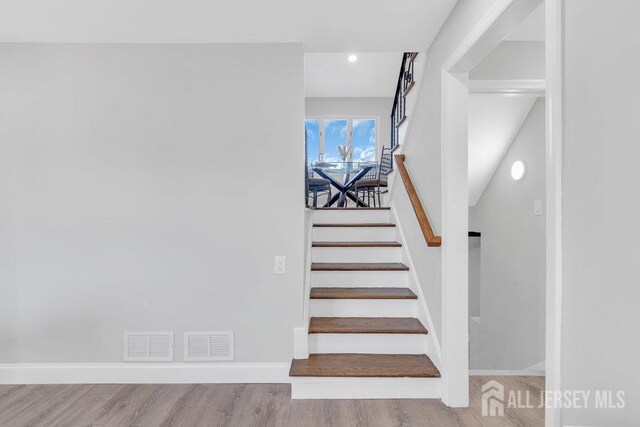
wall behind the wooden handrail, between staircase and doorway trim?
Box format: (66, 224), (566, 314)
(389, 0), (502, 344)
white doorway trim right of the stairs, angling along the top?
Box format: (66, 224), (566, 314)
(440, 0), (542, 406)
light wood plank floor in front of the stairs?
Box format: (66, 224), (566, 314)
(0, 376), (544, 427)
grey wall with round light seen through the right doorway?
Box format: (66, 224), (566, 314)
(469, 98), (545, 370)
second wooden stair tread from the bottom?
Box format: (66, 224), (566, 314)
(309, 317), (428, 334)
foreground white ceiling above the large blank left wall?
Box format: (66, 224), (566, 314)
(0, 0), (456, 52)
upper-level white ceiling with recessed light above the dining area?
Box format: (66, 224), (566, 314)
(304, 52), (402, 97)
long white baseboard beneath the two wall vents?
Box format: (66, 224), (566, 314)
(0, 363), (290, 384)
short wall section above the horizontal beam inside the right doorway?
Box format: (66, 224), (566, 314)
(469, 41), (545, 80)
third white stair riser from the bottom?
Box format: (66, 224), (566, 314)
(309, 299), (418, 317)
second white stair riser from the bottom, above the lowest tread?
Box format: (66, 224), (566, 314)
(309, 334), (427, 354)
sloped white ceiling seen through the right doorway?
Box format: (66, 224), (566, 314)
(469, 95), (536, 206)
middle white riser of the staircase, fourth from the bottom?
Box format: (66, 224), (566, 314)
(311, 271), (409, 288)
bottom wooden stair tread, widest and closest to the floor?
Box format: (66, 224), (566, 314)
(289, 354), (440, 378)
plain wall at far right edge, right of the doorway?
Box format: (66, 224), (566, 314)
(561, 0), (640, 426)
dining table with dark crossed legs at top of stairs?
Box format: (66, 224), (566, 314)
(311, 161), (377, 208)
